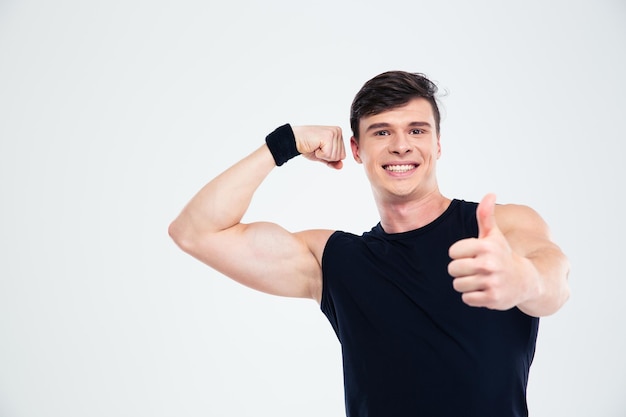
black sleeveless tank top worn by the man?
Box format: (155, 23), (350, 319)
(321, 200), (539, 417)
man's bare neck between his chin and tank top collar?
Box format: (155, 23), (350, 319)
(376, 190), (450, 233)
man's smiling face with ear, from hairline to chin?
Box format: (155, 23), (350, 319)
(350, 98), (441, 200)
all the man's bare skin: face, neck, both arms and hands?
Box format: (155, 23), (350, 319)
(169, 99), (569, 316)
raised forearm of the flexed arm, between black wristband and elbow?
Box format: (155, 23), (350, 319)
(169, 144), (276, 246)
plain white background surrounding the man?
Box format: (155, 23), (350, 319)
(0, 0), (626, 417)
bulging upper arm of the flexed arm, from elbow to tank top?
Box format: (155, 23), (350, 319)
(178, 222), (332, 301)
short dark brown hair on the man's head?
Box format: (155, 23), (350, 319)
(350, 71), (441, 140)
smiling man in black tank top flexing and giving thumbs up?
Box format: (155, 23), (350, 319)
(170, 71), (569, 417)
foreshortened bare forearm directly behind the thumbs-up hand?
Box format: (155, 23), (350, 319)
(518, 247), (569, 317)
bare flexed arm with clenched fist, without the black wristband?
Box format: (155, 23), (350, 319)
(169, 126), (345, 302)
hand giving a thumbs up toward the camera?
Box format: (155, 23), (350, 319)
(448, 194), (530, 310)
